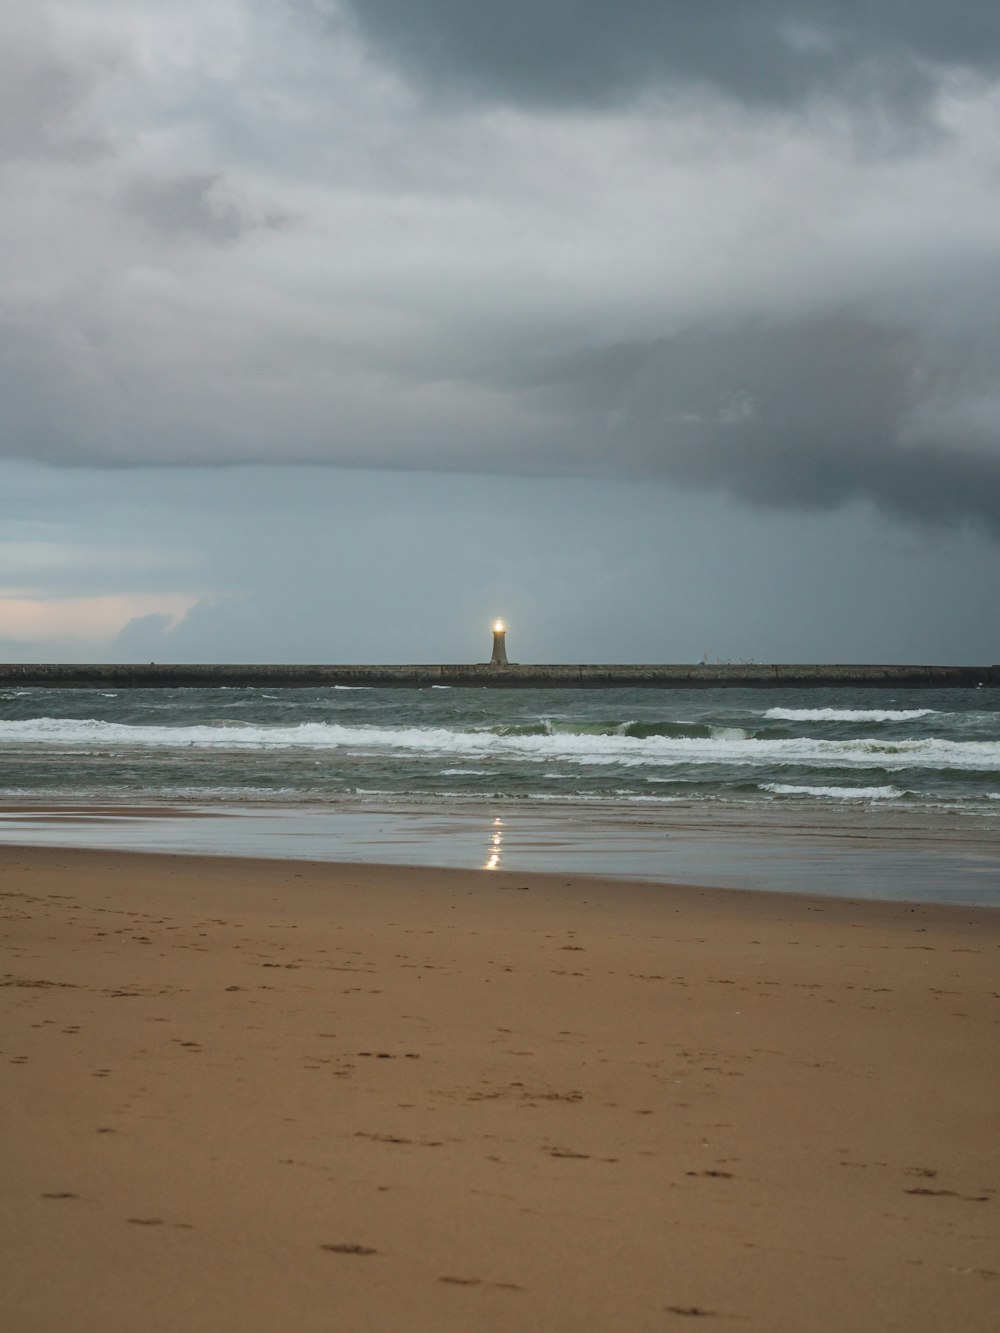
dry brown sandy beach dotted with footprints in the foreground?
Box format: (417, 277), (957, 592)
(0, 846), (1000, 1333)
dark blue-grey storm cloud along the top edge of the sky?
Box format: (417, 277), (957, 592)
(341, 0), (1000, 107)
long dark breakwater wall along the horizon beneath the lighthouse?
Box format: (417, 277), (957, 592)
(0, 663), (1000, 689)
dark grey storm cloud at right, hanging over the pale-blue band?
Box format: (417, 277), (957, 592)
(549, 315), (1000, 537)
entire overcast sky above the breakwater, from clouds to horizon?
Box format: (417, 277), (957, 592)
(0, 0), (1000, 663)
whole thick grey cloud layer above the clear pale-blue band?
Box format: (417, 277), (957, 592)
(0, 0), (1000, 535)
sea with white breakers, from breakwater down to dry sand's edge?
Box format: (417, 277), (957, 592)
(0, 686), (1000, 905)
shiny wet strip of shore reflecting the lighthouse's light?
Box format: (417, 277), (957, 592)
(0, 802), (1000, 905)
